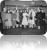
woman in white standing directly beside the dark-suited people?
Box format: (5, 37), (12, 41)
(28, 9), (36, 28)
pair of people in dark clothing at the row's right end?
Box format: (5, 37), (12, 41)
(36, 9), (45, 28)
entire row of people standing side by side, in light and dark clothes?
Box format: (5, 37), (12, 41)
(1, 8), (45, 29)
